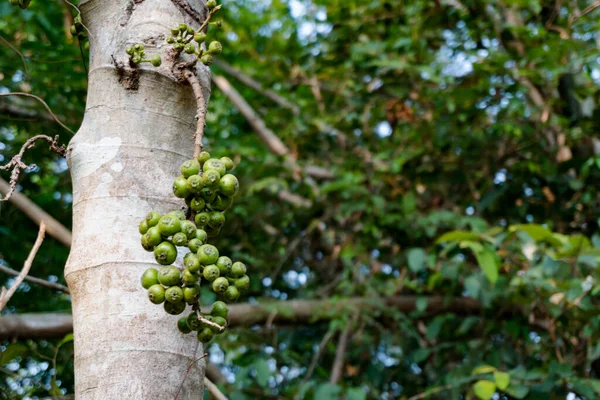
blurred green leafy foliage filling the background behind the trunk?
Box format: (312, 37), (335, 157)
(0, 0), (600, 400)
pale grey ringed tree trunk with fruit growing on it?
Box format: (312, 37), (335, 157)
(65, 0), (210, 400)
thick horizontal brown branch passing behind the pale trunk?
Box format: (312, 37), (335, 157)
(0, 296), (488, 340)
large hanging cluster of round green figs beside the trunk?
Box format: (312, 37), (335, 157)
(139, 151), (250, 343)
